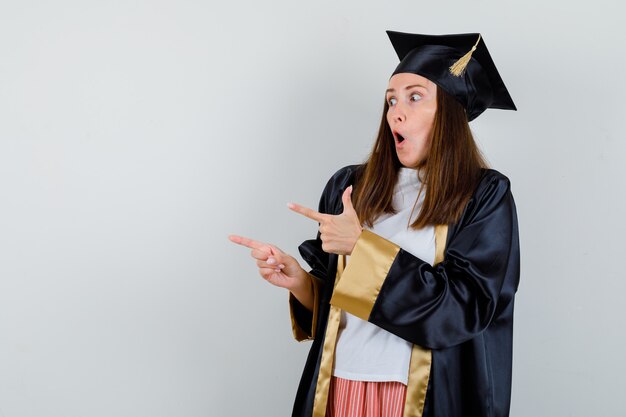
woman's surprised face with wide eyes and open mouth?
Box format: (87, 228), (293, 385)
(386, 72), (437, 168)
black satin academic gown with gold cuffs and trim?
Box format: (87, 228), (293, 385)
(289, 165), (520, 417)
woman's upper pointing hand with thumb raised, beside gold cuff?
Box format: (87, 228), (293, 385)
(287, 186), (363, 255)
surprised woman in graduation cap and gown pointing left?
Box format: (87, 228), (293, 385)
(230, 31), (519, 417)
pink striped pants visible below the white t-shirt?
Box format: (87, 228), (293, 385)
(326, 376), (406, 417)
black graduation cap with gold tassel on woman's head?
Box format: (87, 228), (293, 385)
(387, 30), (517, 121)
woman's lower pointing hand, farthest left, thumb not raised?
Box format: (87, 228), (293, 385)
(228, 235), (309, 291)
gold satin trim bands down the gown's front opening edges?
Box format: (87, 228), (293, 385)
(313, 224), (448, 417)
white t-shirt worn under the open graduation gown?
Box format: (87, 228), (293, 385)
(333, 167), (435, 384)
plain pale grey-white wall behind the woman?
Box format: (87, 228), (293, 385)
(0, 0), (626, 417)
